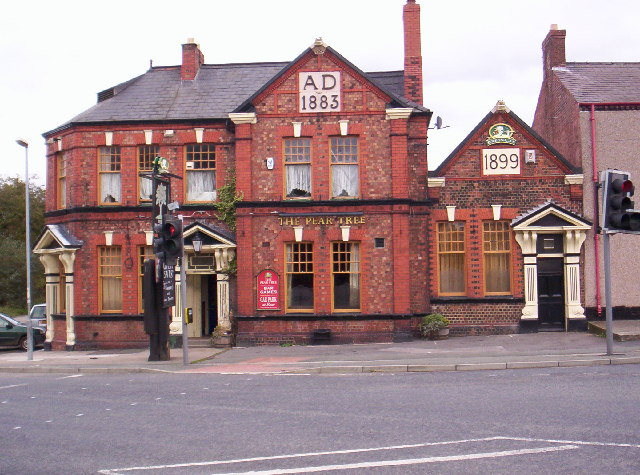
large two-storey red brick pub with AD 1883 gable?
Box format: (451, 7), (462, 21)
(35, 0), (431, 349)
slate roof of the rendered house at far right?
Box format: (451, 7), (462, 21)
(553, 63), (640, 103)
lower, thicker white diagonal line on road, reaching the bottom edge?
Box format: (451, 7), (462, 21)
(212, 445), (578, 475)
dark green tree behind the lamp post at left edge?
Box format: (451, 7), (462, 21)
(0, 178), (45, 308)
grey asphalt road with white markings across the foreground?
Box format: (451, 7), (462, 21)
(0, 365), (640, 475)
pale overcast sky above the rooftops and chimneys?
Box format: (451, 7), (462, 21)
(0, 0), (640, 185)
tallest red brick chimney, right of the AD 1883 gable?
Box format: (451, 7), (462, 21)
(402, 0), (423, 104)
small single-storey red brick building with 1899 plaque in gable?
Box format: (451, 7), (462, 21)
(429, 102), (591, 335)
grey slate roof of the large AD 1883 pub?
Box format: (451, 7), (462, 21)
(44, 49), (416, 137)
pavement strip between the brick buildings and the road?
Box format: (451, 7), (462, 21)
(0, 321), (640, 374)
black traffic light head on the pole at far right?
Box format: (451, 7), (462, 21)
(602, 170), (640, 233)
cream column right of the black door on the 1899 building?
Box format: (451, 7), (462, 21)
(564, 230), (587, 320)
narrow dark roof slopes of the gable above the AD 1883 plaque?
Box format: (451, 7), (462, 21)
(233, 46), (431, 113)
